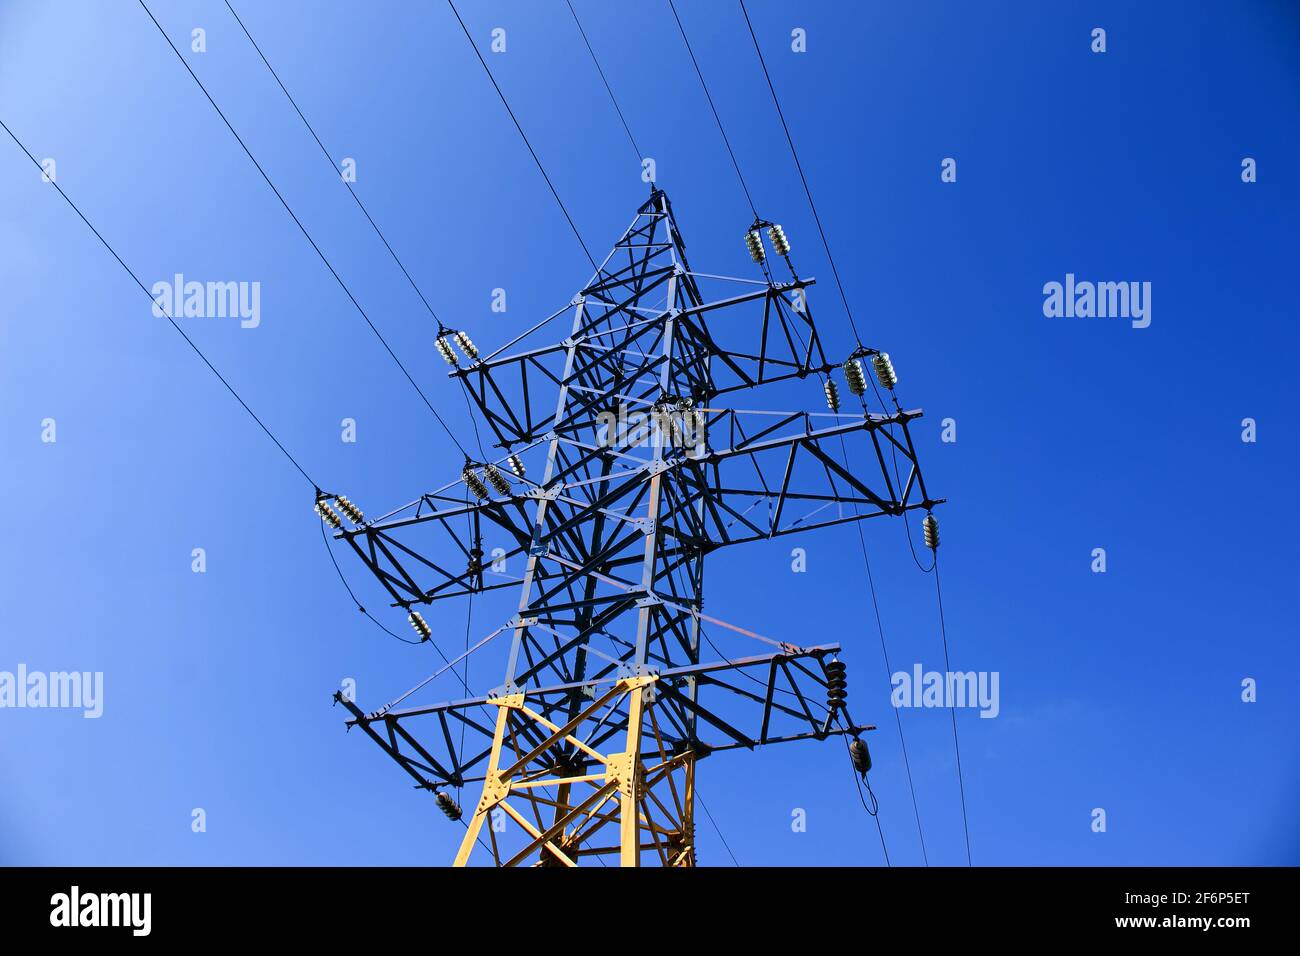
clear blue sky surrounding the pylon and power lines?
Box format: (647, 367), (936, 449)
(0, 0), (1300, 865)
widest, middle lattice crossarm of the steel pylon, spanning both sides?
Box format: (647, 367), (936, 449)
(337, 408), (940, 606)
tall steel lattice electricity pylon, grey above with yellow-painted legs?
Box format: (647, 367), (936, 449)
(324, 189), (939, 866)
